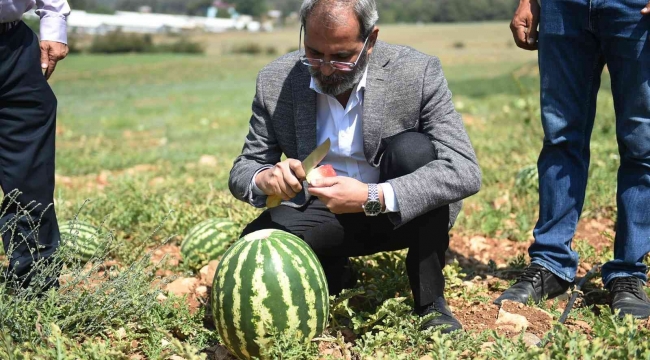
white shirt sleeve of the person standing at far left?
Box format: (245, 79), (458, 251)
(35, 0), (70, 44)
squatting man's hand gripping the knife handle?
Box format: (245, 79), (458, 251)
(255, 159), (307, 201)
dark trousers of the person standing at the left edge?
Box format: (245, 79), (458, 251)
(0, 22), (59, 286)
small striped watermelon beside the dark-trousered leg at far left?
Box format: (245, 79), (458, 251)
(59, 221), (100, 261)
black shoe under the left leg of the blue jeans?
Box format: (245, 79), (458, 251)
(494, 264), (571, 305)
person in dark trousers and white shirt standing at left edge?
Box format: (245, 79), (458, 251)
(0, 0), (70, 288)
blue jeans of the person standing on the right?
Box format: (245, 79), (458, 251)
(529, 0), (650, 284)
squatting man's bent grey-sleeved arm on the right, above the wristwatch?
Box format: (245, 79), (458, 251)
(387, 57), (481, 226)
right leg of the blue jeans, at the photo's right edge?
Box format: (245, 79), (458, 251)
(598, 0), (650, 284)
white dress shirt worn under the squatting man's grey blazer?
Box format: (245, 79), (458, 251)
(252, 68), (399, 212)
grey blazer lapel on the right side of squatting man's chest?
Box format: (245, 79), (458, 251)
(363, 41), (390, 164)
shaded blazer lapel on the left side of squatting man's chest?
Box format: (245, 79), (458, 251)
(291, 66), (317, 160)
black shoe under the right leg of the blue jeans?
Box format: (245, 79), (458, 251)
(607, 276), (650, 319)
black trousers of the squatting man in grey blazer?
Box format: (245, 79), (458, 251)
(242, 133), (449, 307)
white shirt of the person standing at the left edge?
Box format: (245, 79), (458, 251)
(0, 0), (70, 44)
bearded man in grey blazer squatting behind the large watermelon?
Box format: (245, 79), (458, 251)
(229, 0), (481, 332)
